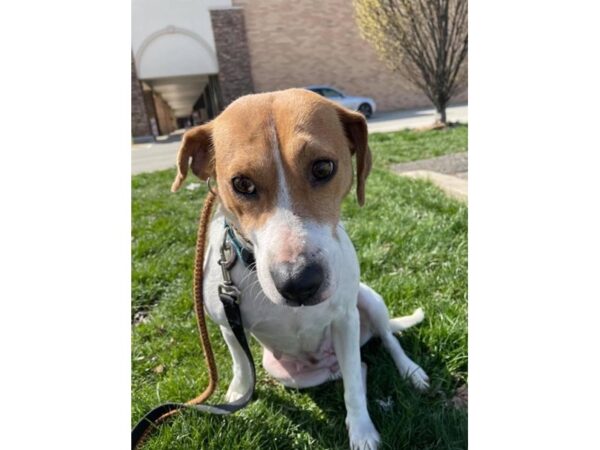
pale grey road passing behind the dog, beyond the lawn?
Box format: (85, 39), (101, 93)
(131, 105), (468, 175)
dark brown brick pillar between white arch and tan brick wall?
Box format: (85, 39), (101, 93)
(210, 8), (254, 107)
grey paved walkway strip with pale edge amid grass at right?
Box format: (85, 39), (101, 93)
(391, 152), (469, 202)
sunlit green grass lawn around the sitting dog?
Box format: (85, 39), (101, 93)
(132, 127), (467, 450)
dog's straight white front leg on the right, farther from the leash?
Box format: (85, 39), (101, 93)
(332, 308), (379, 450)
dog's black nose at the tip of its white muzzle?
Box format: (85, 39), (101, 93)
(271, 262), (325, 305)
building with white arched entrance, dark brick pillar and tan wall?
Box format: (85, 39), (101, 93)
(131, 0), (466, 140)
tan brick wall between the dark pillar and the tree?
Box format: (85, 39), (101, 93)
(233, 0), (465, 111)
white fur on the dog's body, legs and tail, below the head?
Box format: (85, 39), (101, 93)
(204, 208), (428, 449)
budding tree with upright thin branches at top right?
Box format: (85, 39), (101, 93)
(353, 0), (469, 124)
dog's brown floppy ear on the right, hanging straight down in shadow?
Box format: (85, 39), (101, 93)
(336, 105), (371, 206)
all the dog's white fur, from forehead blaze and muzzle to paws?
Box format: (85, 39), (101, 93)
(204, 124), (428, 449)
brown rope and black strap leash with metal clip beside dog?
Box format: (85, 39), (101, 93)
(131, 189), (256, 450)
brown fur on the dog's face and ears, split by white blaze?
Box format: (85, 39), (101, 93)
(173, 89), (371, 237)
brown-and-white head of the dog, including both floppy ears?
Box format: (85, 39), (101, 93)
(172, 89), (371, 306)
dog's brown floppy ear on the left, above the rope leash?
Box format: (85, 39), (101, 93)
(171, 123), (213, 192)
